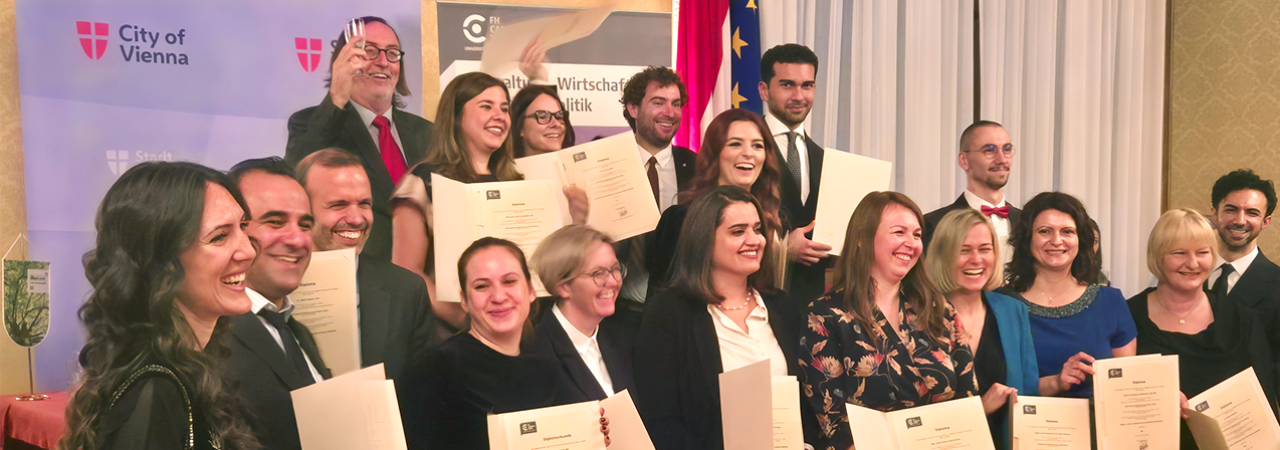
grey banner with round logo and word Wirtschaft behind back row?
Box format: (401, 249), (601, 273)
(436, 1), (672, 143)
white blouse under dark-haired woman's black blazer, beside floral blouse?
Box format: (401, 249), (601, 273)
(707, 291), (787, 376)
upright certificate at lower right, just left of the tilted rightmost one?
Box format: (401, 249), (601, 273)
(1093, 354), (1180, 450)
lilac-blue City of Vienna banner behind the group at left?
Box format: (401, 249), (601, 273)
(15, 0), (422, 391)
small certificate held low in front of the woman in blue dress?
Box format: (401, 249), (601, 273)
(1009, 395), (1092, 450)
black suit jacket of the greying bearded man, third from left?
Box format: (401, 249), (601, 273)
(356, 252), (435, 380)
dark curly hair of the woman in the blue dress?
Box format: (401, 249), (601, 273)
(1005, 192), (1102, 293)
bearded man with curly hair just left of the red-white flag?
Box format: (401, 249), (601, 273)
(616, 66), (698, 302)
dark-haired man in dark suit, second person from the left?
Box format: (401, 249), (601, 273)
(223, 157), (330, 450)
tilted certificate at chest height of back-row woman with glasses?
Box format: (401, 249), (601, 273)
(516, 132), (662, 240)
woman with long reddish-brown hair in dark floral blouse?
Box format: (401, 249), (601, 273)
(799, 192), (978, 450)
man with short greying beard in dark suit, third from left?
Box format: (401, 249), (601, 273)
(297, 148), (435, 380)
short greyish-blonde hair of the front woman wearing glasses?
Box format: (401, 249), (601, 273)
(530, 225), (613, 297)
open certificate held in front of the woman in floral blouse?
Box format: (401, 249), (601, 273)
(849, 396), (996, 450)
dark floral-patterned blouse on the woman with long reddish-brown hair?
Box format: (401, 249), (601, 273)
(799, 291), (978, 450)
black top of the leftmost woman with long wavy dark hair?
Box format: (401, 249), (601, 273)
(92, 364), (223, 450)
